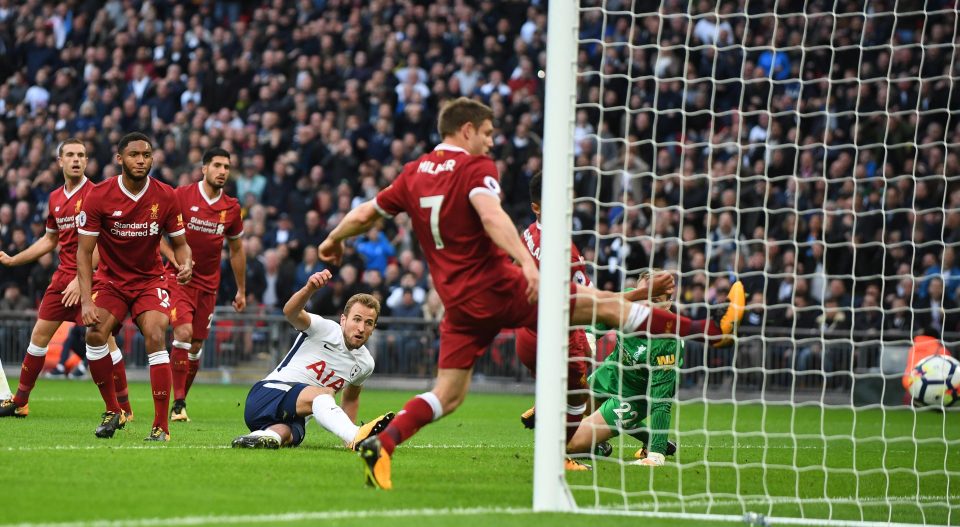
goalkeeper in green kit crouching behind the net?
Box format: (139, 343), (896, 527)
(567, 274), (743, 466)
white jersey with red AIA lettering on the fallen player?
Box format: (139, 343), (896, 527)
(263, 313), (373, 391)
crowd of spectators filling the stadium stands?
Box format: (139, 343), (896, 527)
(0, 0), (960, 352)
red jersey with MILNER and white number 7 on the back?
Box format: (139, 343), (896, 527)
(374, 144), (514, 309)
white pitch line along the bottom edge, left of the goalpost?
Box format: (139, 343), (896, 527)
(0, 507), (533, 527)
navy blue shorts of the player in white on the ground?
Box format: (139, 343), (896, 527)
(243, 381), (307, 446)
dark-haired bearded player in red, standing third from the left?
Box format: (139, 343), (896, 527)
(160, 148), (247, 421)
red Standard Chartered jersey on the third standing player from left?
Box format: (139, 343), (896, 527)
(167, 181), (243, 293)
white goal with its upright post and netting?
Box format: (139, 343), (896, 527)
(534, 0), (960, 524)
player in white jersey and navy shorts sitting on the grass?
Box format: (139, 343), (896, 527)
(233, 270), (394, 448)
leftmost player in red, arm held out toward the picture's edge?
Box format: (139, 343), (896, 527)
(0, 138), (131, 417)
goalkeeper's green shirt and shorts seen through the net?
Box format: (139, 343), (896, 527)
(589, 327), (684, 454)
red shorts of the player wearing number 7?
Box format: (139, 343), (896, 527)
(437, 267), (577, 369)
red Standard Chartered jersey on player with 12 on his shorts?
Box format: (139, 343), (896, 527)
(77, 176), (184, 289)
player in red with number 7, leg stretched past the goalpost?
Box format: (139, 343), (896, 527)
(320, 97), (744, 489)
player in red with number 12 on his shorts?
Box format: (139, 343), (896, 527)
(77, 132), (193, 441)
